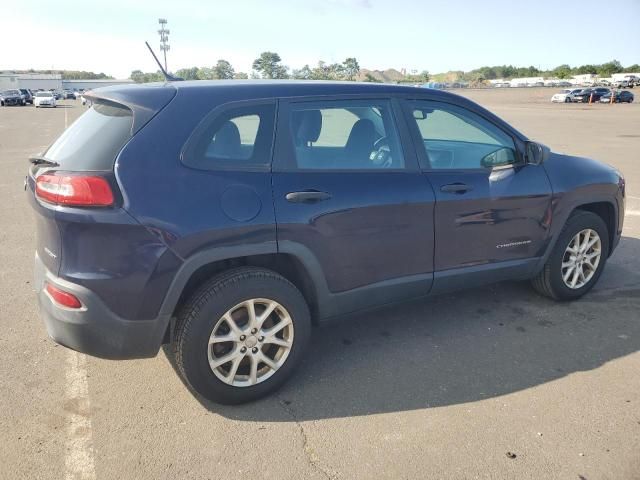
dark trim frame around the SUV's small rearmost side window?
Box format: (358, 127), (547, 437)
(179, 98), (278, 172)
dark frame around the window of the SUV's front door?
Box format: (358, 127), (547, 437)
(400, 96), (527, 173)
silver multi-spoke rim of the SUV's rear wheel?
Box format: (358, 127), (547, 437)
(207, 298), (293, 387)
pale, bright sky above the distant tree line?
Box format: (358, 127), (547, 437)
(0, 0), (640, 78)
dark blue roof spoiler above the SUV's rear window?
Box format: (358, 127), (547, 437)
(83, 83), (177, 135)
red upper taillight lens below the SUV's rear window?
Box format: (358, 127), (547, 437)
(36, 174), (113, 207)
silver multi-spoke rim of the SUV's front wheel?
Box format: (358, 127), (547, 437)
(562, 228), (602, 290)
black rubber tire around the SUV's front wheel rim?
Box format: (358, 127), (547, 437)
(531, 210), (609, 301)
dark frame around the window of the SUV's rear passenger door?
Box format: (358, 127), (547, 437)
(272, 94), (420, 174)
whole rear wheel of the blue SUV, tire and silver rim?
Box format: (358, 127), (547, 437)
(173, 267), (311, 404)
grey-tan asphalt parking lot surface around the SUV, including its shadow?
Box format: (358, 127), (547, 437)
(0, 89), (640, 480)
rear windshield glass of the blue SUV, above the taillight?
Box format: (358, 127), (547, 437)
(44, 100), (133, 171)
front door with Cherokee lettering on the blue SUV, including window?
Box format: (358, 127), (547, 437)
(405, 100), (552, 282)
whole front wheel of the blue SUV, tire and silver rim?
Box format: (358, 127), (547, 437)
(532, 210), (609, 300)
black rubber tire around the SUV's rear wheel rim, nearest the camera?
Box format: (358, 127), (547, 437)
(172, 267), (311, 405)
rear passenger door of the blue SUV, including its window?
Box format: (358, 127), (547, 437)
(272, 98), (435, 317)
